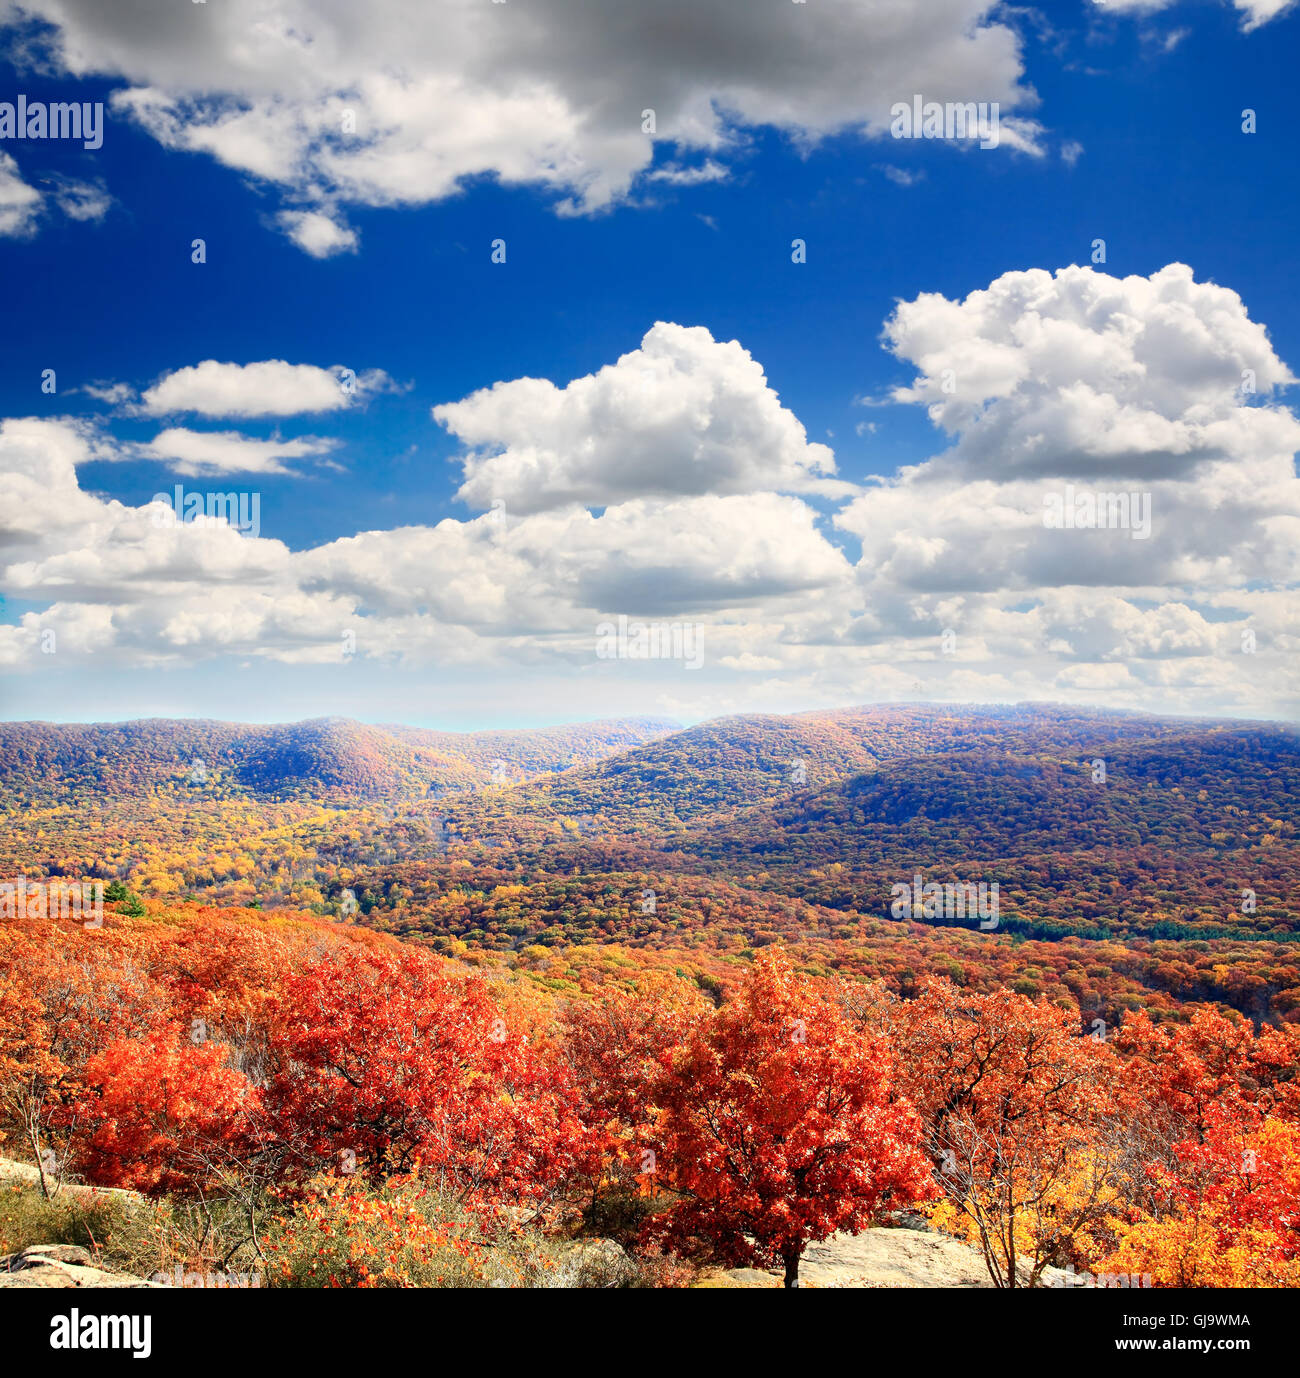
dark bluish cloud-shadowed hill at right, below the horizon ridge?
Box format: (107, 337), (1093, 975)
(688, 719), (1300, 865)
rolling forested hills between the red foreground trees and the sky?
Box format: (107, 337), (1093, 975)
(0, 704), (1300, 1018)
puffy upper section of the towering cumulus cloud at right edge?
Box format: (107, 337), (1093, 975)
(885, 263), (1300, 478)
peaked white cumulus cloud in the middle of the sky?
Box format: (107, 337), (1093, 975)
(433, 321), (845, 513)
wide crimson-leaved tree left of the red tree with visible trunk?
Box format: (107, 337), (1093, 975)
(263, 949), (590, 1206)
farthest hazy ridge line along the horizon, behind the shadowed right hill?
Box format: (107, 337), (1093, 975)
(0, 704), (1293, 815)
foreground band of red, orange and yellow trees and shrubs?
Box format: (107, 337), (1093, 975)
(0, 900), (1300, 1288)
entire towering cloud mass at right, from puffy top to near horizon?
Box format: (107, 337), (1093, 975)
(835, 265), (1300, 707)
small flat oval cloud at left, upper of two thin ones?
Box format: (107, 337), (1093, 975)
(141, 358), (386, 416)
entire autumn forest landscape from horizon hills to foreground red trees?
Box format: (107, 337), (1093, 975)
(0, 704), (1300, 1286)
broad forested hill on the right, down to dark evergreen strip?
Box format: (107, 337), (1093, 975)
(416, 704), (1300, 937)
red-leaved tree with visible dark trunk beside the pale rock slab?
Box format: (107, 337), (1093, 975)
(651, 948), (933, 1287)
